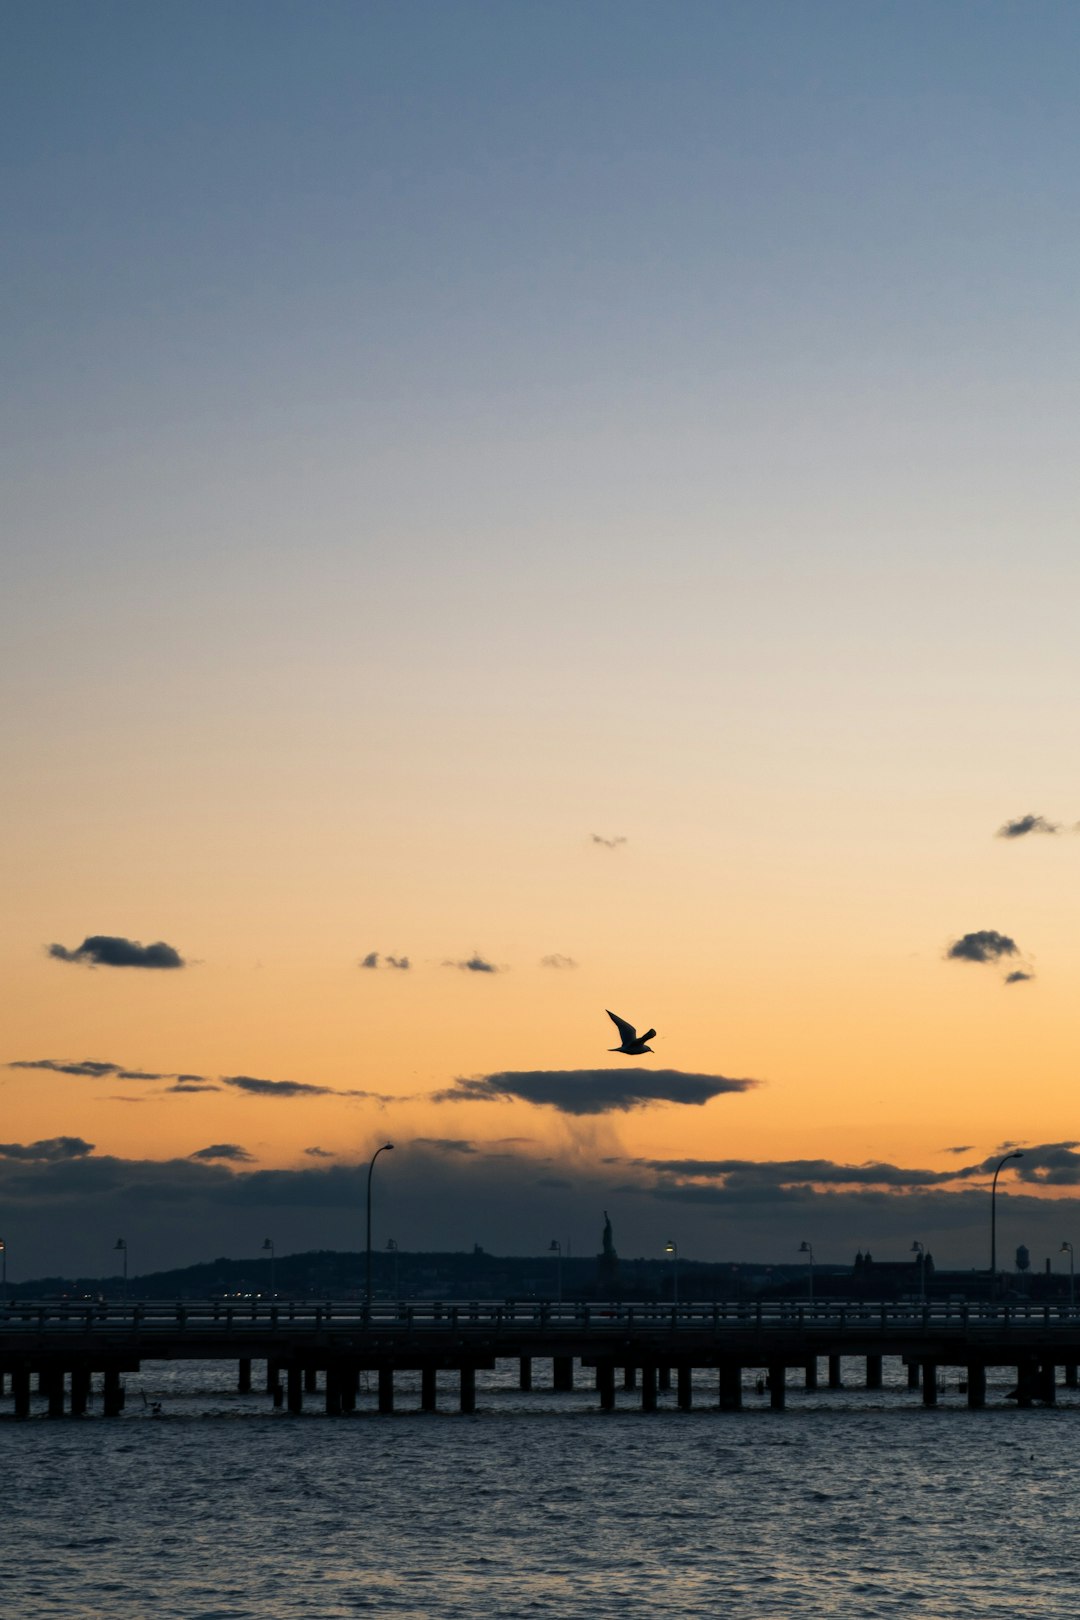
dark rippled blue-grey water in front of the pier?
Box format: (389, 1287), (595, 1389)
(0, 1359), (1080, 1620)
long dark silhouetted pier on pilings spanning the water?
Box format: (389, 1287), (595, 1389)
(0, 1298), (1080, 1418)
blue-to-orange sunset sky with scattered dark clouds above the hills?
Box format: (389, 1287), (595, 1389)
(0, 0), (1080, 1277)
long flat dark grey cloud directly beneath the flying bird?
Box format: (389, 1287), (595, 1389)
(431, 1069), (758, 1115)
